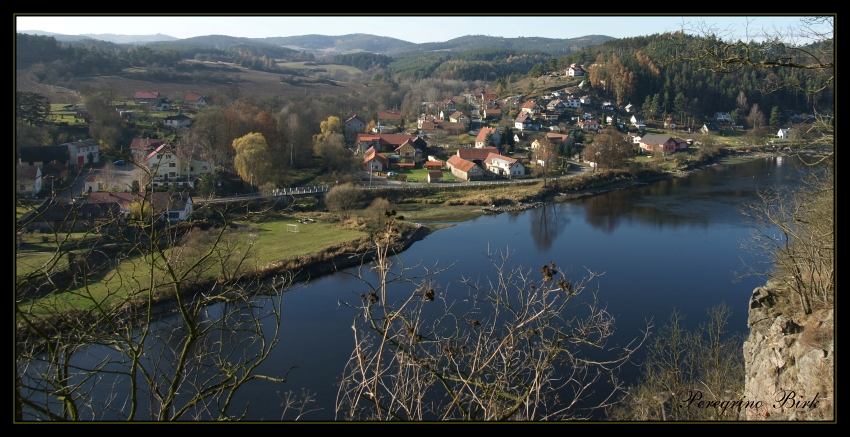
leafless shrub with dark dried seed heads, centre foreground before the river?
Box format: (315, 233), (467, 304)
(336, 212), (648, 420)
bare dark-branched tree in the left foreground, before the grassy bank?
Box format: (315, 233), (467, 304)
(14, 170), (300, 421)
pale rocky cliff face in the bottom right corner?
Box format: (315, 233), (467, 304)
(744, 283), (835, 420)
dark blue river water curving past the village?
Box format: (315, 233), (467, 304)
(33, 158), (798, 420)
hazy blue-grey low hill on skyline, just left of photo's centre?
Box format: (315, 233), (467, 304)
(256, 33), (413, 53)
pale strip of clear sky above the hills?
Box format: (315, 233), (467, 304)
(15, 14), (820, 43)
